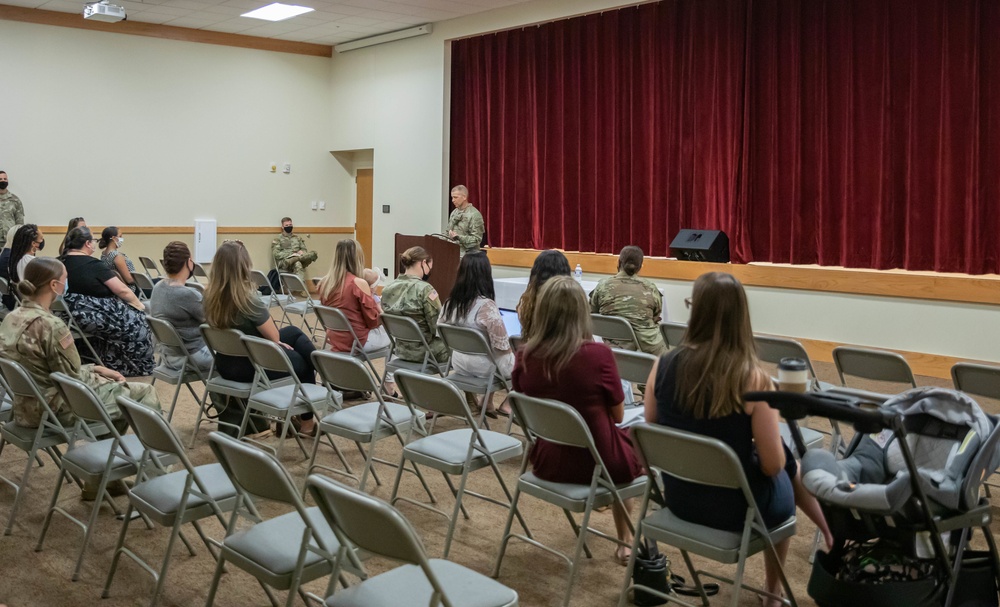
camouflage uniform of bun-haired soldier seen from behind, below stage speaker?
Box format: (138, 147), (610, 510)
(590, 272), (667, 356)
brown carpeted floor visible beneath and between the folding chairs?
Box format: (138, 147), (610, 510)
(0, 338), (998, 607)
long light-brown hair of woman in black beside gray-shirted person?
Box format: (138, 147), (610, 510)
(205, 241), (257, 329)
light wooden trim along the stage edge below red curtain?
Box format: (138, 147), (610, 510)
(487, 248), (1000, 305)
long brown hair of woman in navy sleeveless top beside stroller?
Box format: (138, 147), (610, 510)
(676, 272), (767, 419)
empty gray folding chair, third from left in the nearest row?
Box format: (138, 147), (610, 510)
(101, 396), (236, 607)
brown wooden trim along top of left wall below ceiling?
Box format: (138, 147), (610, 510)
(0, 2), (333, 57)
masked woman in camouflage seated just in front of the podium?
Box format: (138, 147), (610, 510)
(382, 247), (448, 372)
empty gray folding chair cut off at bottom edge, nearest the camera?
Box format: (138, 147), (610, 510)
(306, 474), (518, 607)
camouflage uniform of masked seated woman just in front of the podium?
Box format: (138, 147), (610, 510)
(382, 274), (448, 362)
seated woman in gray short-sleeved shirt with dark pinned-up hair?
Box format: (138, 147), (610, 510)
(149, 240), (213, 373)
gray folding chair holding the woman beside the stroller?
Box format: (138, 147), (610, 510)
(618, 424), (796, 607)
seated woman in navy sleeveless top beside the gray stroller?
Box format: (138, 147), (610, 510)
(645, 272), (833, 605)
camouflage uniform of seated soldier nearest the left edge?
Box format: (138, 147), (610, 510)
(0, 300), (160, 428)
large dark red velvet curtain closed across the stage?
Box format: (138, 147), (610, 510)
(451, 0), (1000, 273)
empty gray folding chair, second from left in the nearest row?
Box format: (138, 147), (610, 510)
(35, 373), (166, 582)
